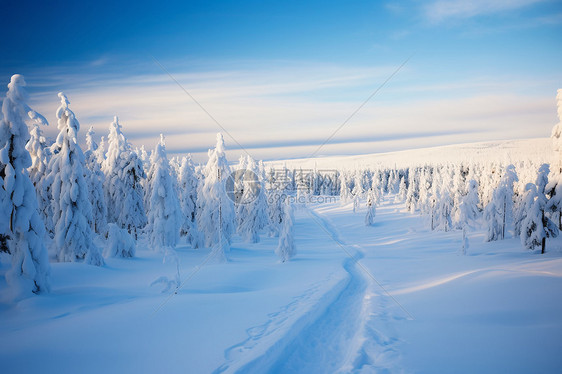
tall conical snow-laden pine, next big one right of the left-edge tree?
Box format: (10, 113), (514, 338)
(49, 92), (104, 266)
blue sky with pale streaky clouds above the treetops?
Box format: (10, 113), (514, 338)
(0, 0), (562, 160)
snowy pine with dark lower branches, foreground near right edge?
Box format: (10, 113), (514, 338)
(521, 164), (559, 253)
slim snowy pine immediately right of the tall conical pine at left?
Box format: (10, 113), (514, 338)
(84, 126), (107, 235)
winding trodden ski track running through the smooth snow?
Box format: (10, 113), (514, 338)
(215, 209), (400, 373)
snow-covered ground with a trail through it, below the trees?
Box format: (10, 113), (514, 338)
(0, 197), (562, 373)
